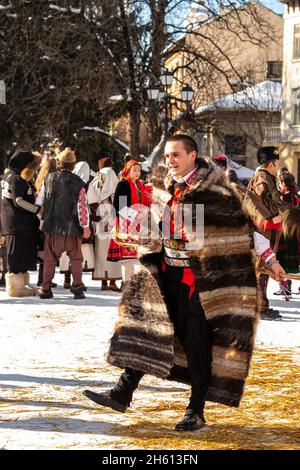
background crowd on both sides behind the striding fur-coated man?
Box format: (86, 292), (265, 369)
(0, 140), (300, 310)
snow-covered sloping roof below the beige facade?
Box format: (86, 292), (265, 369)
(195, 81), (282, 114)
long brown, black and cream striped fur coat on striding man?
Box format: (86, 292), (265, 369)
(108, 159), (257, 406)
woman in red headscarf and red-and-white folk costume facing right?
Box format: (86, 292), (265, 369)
(107, 160), (151, 284)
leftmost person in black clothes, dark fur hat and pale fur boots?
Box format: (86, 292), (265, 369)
(1, 151), (41, 297)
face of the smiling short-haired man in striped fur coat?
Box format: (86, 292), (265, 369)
(165, 141), (197, 178)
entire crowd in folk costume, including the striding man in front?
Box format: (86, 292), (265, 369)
(1, 134), (300, 431)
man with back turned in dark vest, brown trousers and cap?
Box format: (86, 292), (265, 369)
(39, 148), (90, 299)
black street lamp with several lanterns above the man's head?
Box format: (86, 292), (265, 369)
(147, 70), (194, 140)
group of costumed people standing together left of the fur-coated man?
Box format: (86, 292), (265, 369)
(0, 143), (151, 299)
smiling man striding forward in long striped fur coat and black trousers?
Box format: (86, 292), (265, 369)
(84, 134), (280, 431)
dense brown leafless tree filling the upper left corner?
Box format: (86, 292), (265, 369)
(0, 0), (123, 165)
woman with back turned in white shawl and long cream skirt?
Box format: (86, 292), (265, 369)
(87, 157), (122, 292)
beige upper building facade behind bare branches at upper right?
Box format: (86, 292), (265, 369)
(165, 2), (283, 108)
